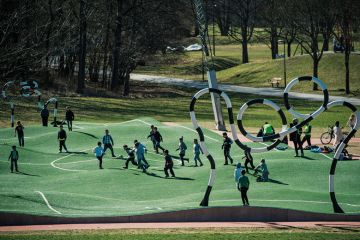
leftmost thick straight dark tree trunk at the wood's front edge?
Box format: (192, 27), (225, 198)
(76, 0), (86, 93)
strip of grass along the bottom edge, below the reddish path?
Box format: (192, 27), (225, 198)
(0, 228), (360, 240)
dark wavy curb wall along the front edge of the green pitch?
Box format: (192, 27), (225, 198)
(0, 207), (360, 226)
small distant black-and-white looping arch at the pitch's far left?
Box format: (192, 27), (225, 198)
(1, 80), (41, 127)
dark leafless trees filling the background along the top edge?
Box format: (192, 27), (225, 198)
(0, 0), (360, 96)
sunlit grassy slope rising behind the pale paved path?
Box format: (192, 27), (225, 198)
(136, 44), (360, 96)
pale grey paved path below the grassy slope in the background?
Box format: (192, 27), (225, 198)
(131, 74), (360, 105)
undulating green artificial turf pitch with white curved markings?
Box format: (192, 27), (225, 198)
(0, 118), (360, 217)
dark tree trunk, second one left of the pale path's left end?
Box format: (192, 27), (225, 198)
(111, 0), (123, 91)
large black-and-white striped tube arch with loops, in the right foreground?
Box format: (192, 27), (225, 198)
(190, 76), (360, 213)
